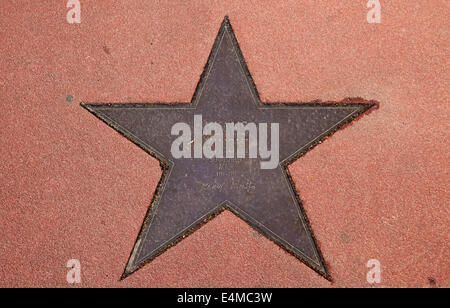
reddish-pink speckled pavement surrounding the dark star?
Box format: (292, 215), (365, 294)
(0, 0), (450, 287)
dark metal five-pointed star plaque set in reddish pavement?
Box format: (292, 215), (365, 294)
(82, 17), (375, 279)
